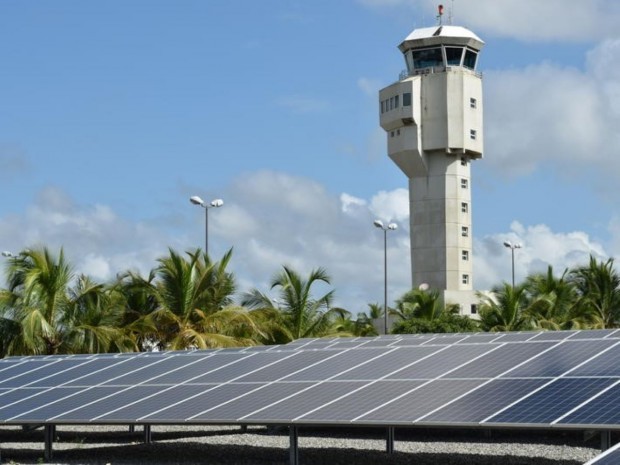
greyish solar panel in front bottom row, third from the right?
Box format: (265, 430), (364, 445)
(422, 379), (549, 423)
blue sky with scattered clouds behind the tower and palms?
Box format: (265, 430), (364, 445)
(0, 0), (620, 313)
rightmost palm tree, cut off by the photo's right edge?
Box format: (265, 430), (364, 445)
(570, 256), (620, 329)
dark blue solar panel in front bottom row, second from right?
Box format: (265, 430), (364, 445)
(488, 378), (615, 424)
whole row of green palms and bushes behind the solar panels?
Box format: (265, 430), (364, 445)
(0, 243), (620, 357)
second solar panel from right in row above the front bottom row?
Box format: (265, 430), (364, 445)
(505, 339), (617, 378)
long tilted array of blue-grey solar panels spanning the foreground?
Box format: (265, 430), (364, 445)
(0, 330), (620, 430)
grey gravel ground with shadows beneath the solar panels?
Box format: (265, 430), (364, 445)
(0, 426), (600, 465)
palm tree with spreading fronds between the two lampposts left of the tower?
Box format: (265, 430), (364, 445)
(241, 266), (348, 340)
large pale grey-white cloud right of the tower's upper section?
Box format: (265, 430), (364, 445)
(485, 40), (620, 177)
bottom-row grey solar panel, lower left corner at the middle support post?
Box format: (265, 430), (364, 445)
(299, 381), (424, 423)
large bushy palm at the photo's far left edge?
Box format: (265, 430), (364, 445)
(0, 247), (135, 355)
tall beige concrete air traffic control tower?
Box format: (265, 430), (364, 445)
(379, 25), (484, 315)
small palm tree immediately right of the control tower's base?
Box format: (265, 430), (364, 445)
(479, 283), (533, 331)
